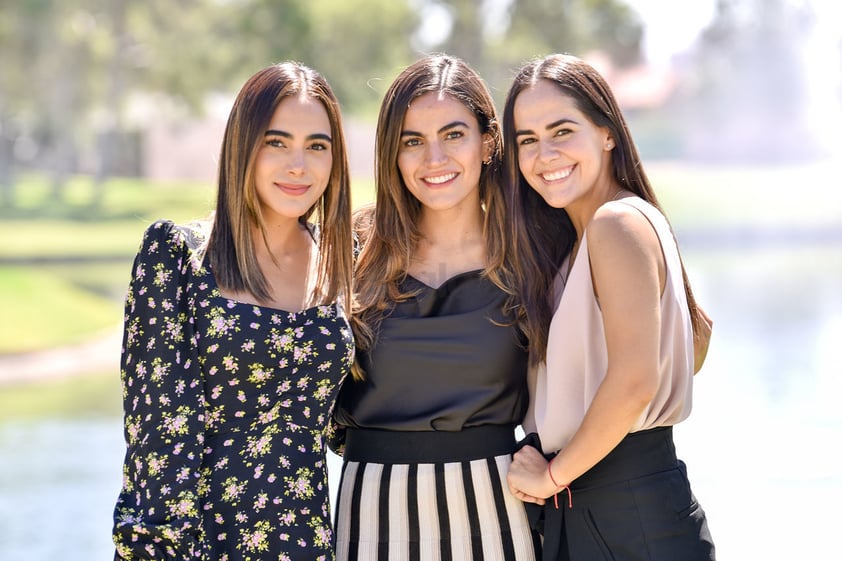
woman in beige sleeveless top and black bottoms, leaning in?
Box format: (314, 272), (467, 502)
(504, 55), (714, 560)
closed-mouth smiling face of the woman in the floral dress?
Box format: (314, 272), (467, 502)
(254, 95), (333, 222)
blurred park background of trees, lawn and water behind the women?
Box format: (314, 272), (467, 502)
(0, 0), (842, 561)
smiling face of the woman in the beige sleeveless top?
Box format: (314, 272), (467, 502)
(513, 80), (614, 208)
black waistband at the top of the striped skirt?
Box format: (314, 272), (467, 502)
(343, 425), (515, 464)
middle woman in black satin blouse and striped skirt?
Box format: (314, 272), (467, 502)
(335, 55), (537, 561)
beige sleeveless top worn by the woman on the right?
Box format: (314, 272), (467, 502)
(523, 197), (693, 452)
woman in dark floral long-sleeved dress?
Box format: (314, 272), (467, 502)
(113, 62), (354, 561)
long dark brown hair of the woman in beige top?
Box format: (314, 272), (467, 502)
(503, 54), (701, 364)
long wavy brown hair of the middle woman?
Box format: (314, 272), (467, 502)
(353, 54), (513, 364)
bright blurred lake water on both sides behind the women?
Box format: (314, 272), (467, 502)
(0, 242), (842, 561)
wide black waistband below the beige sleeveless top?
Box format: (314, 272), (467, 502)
(570, 427), (678, 490)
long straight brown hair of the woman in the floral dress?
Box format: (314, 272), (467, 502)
(206, 62), (353, 303)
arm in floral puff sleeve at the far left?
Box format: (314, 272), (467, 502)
(113, 222), (204, 560)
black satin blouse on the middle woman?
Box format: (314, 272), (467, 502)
(335, 271), (528, 431)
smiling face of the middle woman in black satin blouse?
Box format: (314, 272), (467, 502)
(398, 92), (491, 214)
